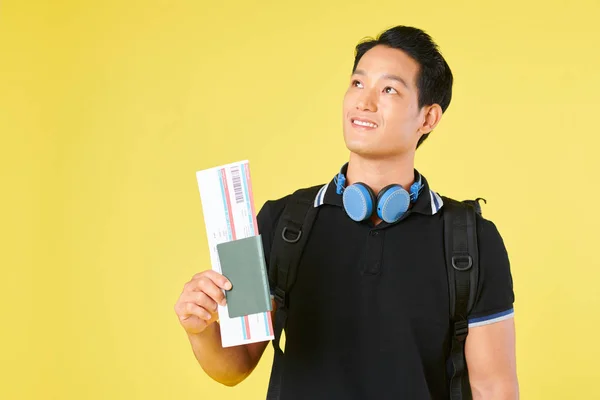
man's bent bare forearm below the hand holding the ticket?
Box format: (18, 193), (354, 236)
(188, 322), (253, 386)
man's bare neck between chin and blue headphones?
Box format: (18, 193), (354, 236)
(346, 153), (415, 195)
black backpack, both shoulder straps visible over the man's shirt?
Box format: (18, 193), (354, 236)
(267, 186), (485, 400)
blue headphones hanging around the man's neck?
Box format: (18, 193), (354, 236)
(335, 163), (423, 223)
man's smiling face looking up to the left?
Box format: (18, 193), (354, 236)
(343, 45), (428, 158)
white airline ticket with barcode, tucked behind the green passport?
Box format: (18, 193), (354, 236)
(196, 160), (274, 347)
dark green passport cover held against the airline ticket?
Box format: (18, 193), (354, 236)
(217, 235), (271, 318)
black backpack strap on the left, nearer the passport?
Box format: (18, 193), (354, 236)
(267, 186), (323, 400)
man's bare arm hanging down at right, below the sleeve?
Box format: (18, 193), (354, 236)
(465, 318), (519, 400)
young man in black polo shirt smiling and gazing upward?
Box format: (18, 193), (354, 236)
(175, 26), (518, 399)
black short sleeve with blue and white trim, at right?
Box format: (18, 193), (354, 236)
(468, 216), (515, 327)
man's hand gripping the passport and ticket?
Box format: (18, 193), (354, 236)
(175, 270), (231, 335)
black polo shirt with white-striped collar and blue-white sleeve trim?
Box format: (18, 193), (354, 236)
(257, 170), (514, 400)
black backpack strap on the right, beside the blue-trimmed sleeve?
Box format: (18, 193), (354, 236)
(443, 198), (481, 400)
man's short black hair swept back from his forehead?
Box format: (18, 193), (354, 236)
(352, 25), (453, 148)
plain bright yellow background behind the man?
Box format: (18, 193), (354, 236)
(0, 0), (600, 400)
